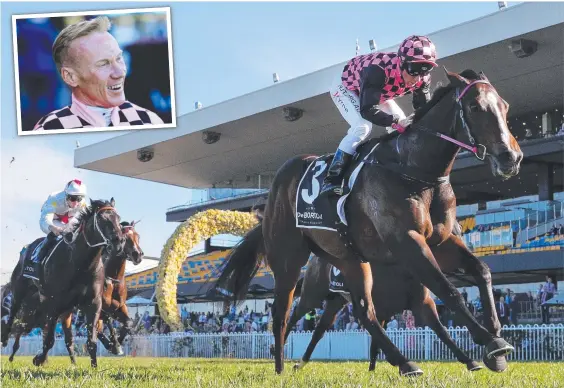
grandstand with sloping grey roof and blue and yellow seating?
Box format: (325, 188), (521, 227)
(75, 2), (564, 302)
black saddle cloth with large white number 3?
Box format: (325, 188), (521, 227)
(295, 144), (378, 232)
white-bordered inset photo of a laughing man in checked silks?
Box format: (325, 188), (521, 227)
(12, 7), (176, 135)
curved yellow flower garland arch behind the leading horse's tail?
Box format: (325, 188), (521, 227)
(156, 209), (258, 331)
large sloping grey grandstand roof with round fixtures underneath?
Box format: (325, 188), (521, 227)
(75, 2), (564, 194)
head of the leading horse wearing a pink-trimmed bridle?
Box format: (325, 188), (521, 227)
(445, 68), (523, 179)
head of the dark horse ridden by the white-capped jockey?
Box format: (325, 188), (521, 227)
(83, 197), (125, 256)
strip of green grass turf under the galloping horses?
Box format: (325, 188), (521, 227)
(1, 357), (564, 388)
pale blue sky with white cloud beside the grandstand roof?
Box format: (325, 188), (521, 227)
(0, 1), (516, 284)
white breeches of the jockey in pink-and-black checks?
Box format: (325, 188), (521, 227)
(330, 74), (406, 155)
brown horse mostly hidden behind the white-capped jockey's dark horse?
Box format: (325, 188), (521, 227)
(4, 222), (143, 364)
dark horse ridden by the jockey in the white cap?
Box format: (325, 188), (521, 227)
(2, 198), (125, 367)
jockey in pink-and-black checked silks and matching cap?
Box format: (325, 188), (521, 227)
(321, 35), (437, 194)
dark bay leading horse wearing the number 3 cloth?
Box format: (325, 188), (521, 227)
(216, 69), (523, 375)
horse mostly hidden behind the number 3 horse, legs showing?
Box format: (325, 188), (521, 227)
(284, 256), (482, 372)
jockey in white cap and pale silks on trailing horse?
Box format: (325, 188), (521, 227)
(24, 179), (87, 280)
